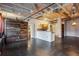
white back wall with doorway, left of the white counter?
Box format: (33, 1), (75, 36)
(29, 19), (49, 38)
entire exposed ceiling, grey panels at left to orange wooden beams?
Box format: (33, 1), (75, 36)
(0, 3), (79, 20)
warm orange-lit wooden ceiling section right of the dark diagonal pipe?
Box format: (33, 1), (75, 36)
(39, 3), (79, 21)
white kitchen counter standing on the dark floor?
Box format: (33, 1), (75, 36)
(36, 31), (55, 42)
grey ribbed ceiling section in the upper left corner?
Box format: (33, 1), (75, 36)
(0, 3), (34, 16)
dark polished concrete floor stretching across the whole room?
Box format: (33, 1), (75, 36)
(1, 37), (79, 56)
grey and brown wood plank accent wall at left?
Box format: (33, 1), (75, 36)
(6, 19), (28, 42)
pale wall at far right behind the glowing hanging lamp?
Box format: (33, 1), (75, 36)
(65, 18), (79, 37)
